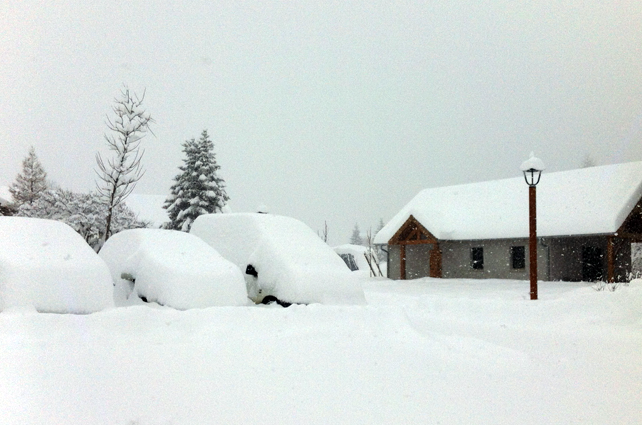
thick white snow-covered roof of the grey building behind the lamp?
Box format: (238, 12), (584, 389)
(375, 162), (642, 244)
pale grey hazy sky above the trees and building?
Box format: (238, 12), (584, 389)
(0, 0), (642, 244)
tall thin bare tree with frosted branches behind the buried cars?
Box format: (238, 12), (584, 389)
(96, 87), (154, 242)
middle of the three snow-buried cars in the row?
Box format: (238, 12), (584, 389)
(99, 229), (249, 310)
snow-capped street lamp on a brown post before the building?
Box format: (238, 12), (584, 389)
(520, 152), (546, 300)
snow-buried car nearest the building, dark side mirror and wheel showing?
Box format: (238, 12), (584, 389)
(190, 213), (365, 304)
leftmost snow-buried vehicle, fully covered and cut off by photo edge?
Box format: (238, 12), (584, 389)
(0, 217), (113, 313)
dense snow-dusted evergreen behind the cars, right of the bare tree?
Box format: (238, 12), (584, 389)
(163, 130), (230, 232)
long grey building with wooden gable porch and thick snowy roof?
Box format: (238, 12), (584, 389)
(375, 162), (642, 281)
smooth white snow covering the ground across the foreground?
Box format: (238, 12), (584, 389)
(0, 272), (642, 425)
